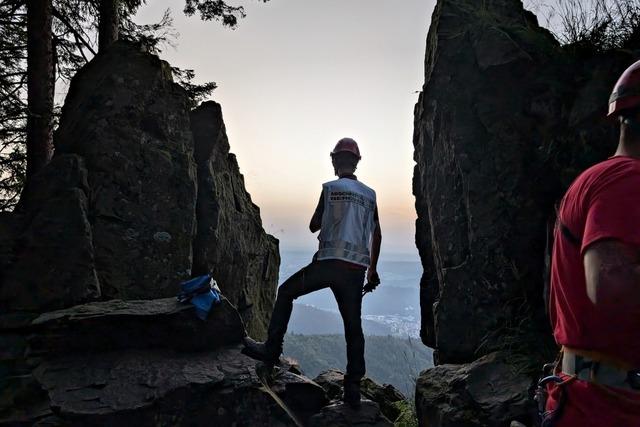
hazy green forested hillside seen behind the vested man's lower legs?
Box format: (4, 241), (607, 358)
(284, 334), (433, 397)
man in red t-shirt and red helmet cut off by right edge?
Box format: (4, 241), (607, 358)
(543, 61), (640, 427)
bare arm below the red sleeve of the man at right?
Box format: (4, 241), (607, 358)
(583, 240), (640, 313)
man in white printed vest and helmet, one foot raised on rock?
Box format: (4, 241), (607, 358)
(243, 138), (382, 407)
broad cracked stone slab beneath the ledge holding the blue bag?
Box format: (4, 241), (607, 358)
(27, 346), (326, 426)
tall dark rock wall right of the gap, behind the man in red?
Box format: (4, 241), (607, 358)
(413, 0), (638, 426)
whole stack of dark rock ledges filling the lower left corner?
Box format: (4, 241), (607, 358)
(0, 298), (395, 427)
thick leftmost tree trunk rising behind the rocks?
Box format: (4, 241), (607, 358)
(27, 0), (55, 180)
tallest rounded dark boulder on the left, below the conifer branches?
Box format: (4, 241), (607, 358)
(55, 44), (196, 299)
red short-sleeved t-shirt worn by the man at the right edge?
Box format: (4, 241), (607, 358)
(549, 156), (640, 367)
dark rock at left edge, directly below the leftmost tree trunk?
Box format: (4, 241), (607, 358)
(0, 154), (100, 313)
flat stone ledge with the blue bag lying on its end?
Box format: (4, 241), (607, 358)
(29, 298), (244, 356)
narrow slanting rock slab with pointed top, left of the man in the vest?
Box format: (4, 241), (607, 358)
(191, 102), (280, 340)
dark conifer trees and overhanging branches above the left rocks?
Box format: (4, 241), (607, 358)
(0, 0), (268, 211)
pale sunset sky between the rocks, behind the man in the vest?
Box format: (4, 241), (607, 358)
(136, 0), (435, 256)
